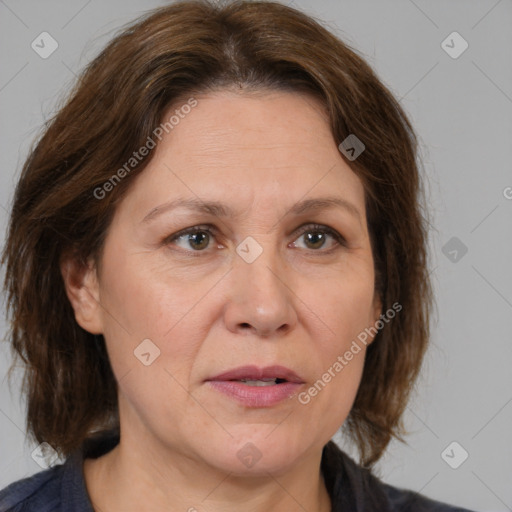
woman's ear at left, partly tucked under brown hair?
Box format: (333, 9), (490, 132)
(60, 254), (103, 334)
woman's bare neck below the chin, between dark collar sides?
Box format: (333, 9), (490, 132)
(84, 435), (331, 512)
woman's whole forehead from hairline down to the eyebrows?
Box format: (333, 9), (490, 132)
(118, 91), (364, 222)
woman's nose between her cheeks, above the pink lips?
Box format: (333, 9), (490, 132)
(224, 241), (297, 337)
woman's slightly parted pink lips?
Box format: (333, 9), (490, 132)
(206, 366), (304, 408)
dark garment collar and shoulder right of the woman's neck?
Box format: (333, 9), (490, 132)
(322, 441), (471, 512)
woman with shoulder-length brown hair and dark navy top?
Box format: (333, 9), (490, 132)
(0, 1), (474, 512)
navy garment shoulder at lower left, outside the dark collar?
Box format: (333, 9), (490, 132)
(0, 465), (63, 512)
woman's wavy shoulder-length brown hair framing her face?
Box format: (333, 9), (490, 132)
(2, 0), (432, 467)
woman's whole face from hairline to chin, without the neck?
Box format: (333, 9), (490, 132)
(67, 91), (380, 474)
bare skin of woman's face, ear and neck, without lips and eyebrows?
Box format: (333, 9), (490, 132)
(62, 91), (381, 512)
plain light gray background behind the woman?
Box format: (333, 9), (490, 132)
(0, 0), (512, 511)
